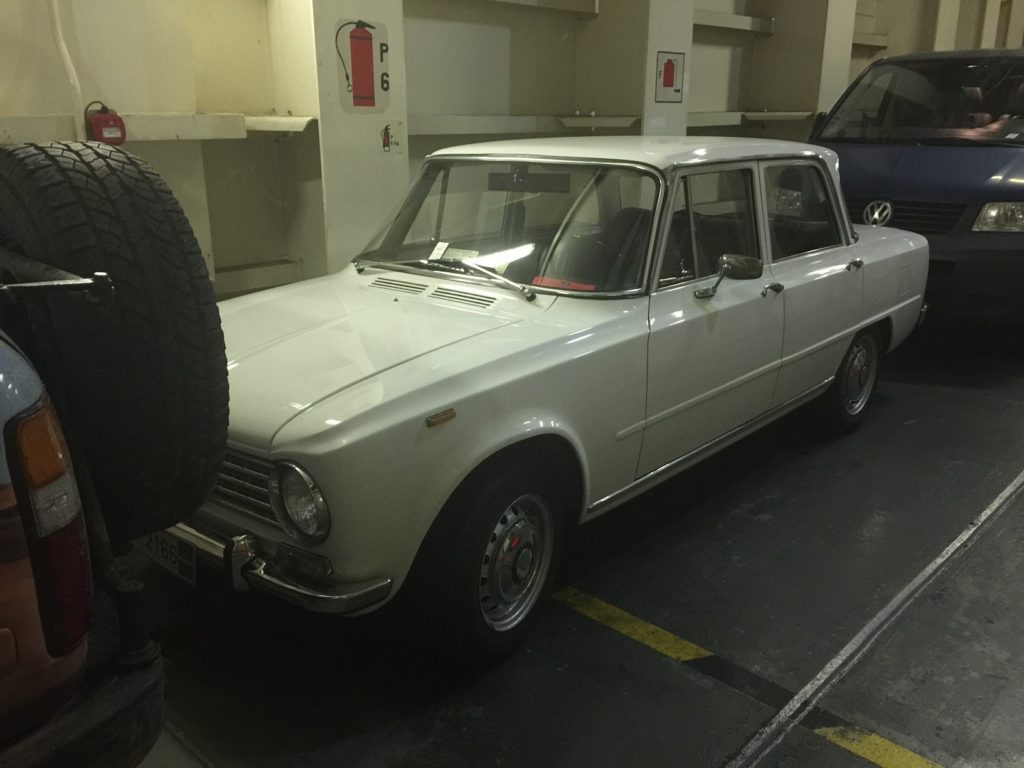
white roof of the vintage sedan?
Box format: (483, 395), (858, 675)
(430, 136), (834, 168)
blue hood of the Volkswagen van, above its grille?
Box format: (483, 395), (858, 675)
(824, 142), (1024, 204)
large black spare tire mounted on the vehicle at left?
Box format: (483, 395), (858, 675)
(0, 142), (227, 543)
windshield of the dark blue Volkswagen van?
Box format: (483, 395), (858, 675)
(819, 57), (1024, 144)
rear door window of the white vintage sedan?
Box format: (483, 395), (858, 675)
(765, 164), (842, 261)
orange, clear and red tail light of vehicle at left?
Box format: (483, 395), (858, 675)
(12, 403), (92, 657)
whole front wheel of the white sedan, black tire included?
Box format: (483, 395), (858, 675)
(408, 462), (565, 669)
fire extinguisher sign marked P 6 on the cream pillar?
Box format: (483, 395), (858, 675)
(334, 18), (391, 114)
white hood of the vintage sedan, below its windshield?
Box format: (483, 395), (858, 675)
(220, 269), (528, 451)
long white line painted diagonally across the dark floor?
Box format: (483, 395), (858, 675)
(725, 471), (1024, 768)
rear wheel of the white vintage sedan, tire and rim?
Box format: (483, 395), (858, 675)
(819, 328), (882, 434)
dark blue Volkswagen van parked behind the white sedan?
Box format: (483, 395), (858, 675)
(811, 50), (1024, 321)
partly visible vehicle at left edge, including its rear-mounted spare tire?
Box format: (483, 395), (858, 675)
(0, 143), (227, 768)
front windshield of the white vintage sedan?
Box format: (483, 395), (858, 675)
(357, 159), (659, 294)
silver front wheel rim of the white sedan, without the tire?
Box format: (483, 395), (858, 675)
(479, 494), (552, 632)
